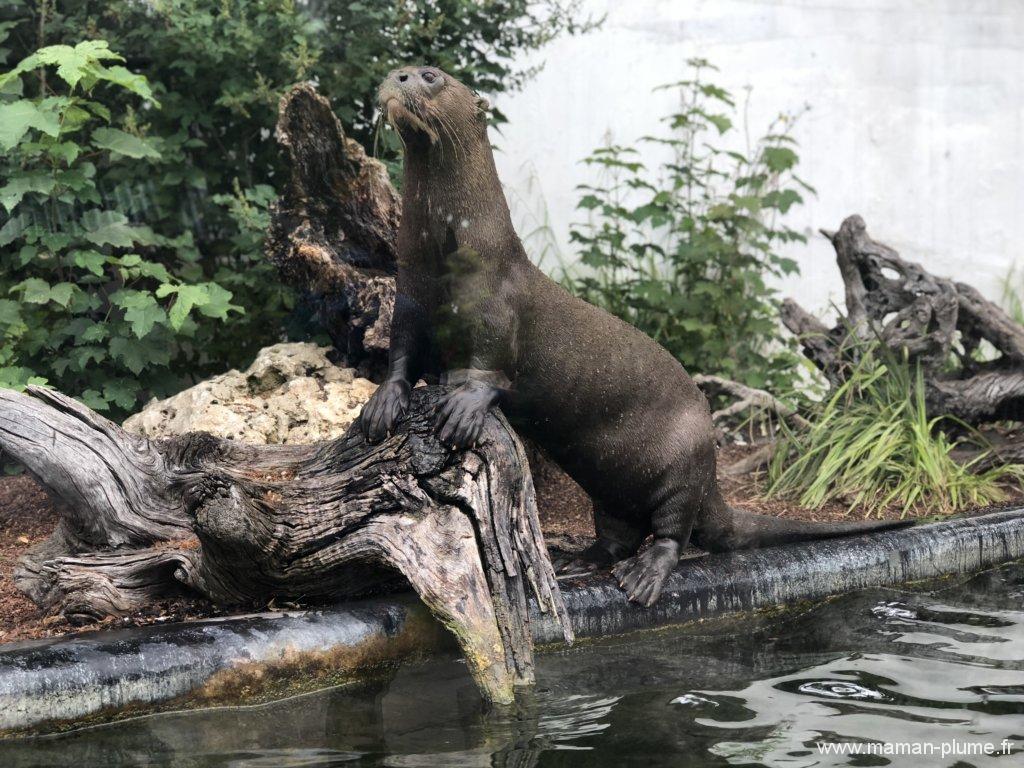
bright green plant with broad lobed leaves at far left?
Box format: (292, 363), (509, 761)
(0, 41), (242, 414)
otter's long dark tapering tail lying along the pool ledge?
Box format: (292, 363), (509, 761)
(693, 494), (913, 552)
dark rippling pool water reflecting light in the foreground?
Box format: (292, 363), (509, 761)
(8, 563), (1024, 768)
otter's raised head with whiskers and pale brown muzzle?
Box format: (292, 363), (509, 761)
(378, 67), (489, 146)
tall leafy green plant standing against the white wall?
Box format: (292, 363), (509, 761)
(564, 59), (813, 390)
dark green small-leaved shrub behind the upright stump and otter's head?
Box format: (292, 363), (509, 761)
(0, 0), (587, 368)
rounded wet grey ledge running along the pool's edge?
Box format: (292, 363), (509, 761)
(0, 508), (1024, 737)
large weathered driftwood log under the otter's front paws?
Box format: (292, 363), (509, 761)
(0, 387), (571, 702)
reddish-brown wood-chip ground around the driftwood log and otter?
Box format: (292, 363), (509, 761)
(0, 445), (1020, 643)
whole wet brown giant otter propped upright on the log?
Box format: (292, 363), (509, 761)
(359, 67), (905, 605)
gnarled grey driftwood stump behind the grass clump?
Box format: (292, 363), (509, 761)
(781, 215), (1024, 434)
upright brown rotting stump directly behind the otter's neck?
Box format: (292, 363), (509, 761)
(266, 84), (401, 375)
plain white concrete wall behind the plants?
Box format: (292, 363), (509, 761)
(496, 0), (1024, 309)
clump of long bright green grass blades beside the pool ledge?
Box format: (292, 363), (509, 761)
(767, 345), (1024, 517)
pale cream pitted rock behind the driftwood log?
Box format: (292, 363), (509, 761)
(124, 343), (377, 444)
